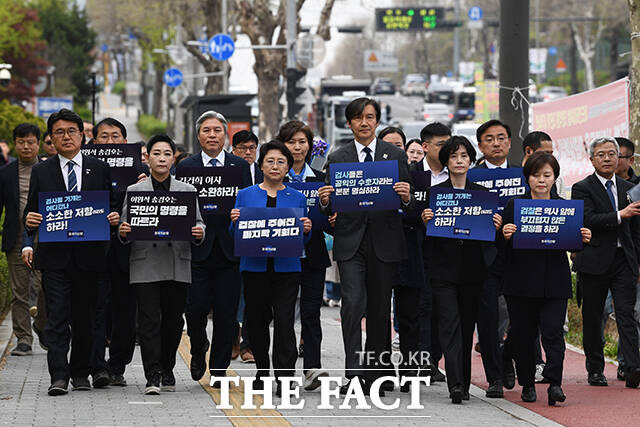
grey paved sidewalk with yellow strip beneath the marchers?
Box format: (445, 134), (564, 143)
(0, 307), (557, 427)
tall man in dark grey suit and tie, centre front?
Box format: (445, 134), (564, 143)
(318, 98), (415, 394)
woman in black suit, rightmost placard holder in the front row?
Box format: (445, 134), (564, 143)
(502, 151), (591, 405)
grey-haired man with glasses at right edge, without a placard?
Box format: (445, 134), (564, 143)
(571, 137), (640, 388)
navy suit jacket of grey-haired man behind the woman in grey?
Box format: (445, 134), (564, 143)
(178, 152), (257, 262)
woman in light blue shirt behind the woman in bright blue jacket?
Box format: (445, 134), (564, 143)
(277, 120), (331, 390)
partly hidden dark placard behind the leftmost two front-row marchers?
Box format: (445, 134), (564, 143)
(80, 144), (142, 191)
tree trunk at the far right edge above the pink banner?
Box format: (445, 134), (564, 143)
(628, 0), (640, 145)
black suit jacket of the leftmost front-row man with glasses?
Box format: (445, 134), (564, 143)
(22, 154), (117, 272)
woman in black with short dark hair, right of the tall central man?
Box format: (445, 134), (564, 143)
(422, 136), (502, 403)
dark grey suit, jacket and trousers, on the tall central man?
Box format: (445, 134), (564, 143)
(322, 140), (415, 380)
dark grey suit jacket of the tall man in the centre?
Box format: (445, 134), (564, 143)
(321, 139), (416, 262)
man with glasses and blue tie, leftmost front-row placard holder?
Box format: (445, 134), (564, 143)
(24, 109), (120, 396)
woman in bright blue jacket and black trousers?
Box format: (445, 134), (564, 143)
(230, 141), (311, 396)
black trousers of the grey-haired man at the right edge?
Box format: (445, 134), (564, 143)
(578, 248), (640, 373)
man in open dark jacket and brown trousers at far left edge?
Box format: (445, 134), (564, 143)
(0, 123), (45, 356)
